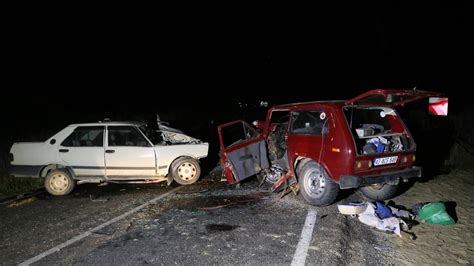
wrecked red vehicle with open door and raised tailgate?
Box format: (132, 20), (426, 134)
(218, 89), (440, 206)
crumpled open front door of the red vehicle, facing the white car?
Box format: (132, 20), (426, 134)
(218, 120), (269, 184)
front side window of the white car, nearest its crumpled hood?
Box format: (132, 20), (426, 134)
(107, 126), (150, 147)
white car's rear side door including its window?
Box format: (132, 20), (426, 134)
(58, 126), (105, 177)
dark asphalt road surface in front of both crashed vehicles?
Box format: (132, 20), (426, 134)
(0, 176), (396, 265)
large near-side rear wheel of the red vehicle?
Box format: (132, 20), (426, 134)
(296, 161), (339, 206)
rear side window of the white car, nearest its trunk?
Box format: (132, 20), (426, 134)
(61, 126), (104, 147)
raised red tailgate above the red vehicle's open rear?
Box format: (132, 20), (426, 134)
(346, 89), (441, 106)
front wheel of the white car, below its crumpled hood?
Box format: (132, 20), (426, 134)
(171, 157), (201, 185)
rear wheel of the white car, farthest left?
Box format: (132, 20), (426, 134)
(44, 169), (76, 196)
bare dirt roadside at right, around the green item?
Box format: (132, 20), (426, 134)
(386, 171), (474, 265)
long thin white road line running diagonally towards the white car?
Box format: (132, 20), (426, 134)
(20, 186), (183, 266)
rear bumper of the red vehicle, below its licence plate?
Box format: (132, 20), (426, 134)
(339, 166), (421, 189)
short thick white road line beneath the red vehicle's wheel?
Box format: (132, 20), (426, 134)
(291, 209), (317, 266)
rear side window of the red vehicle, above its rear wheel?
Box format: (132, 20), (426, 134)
(290, 110), (328, 135)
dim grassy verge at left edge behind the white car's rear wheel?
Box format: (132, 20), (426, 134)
(0, 174), (44, 199)
